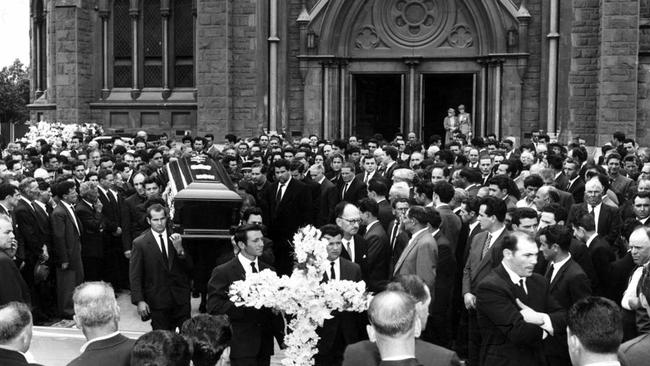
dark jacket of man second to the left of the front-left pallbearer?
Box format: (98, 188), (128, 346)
(74, 200), (104, 258)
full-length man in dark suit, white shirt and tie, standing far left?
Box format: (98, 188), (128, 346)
(50, 181), (84, 319)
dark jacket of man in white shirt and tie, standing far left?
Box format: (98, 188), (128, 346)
(50, 203), (83, 270)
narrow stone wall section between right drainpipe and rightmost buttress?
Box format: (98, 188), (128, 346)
(560, 0), (601, 144)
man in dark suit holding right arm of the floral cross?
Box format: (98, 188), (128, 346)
(314, 225), (362, 366)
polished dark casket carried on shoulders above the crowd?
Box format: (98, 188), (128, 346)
(166, 155), (242, 239)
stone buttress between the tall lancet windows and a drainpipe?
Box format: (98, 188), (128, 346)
(196, 0), (231, 134)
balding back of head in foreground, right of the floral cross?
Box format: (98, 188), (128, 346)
(368, 291), (416, 337)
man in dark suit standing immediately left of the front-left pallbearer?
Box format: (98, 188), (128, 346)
(97, 169), (129, 289)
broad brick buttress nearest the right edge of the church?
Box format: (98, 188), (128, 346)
(596, 0), (639, 145)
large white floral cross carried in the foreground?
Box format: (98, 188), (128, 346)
(229, 226), (370, 366)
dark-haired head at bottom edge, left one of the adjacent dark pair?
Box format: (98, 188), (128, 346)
(131, 330), (192, 366)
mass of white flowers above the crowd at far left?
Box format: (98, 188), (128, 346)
(20, 121), (104, 147)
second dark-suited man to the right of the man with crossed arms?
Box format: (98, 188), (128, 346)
(572, 213), (616, 298)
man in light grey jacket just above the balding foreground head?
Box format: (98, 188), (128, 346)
(393, 206), (438, 294)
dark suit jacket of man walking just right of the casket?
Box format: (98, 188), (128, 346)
(262, 178), (312, 245)
